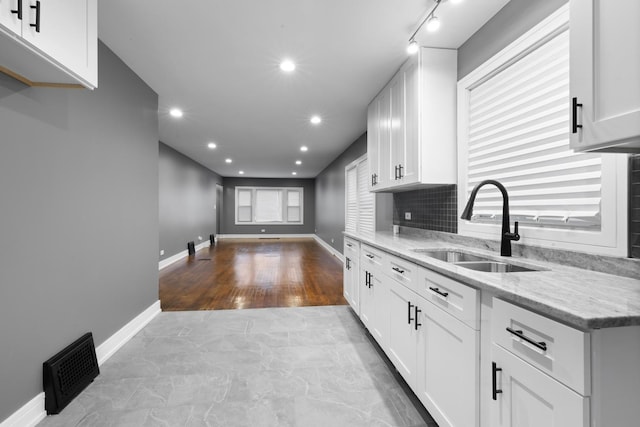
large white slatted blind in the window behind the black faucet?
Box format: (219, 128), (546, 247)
(466, 30), (602, 229)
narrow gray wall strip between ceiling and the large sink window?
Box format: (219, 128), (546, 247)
(458, 0), (568, 80)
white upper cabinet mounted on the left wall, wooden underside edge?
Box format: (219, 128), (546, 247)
(0, 0), (98, 89)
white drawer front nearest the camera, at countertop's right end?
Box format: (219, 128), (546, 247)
(491, 298), (591, 396)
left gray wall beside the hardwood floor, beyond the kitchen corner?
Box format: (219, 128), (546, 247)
(159, 142), (222, 259)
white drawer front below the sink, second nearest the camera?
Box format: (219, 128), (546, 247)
(417, 268), (480, 330)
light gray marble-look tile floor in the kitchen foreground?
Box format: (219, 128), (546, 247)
(38, 306), (437, 427)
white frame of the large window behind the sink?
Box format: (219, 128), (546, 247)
(458, 5), (627, 256)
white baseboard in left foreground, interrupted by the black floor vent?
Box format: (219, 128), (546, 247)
(0, 300), (160, 427)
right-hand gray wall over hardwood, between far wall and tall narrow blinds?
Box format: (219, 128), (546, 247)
(316, 133), (367, 253)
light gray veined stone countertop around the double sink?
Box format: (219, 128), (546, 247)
(344, 232), (640, 330)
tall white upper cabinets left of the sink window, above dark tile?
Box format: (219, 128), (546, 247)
(367, 48), (457, 191)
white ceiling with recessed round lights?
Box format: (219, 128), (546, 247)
(98, 0), (508, 178)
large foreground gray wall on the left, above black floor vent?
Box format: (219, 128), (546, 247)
(0, 44), (158, 421)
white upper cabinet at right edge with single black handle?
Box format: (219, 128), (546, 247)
(570, 0), (640, 152)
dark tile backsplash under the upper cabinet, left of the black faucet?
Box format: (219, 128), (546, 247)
(393, 185), (458, 233)
